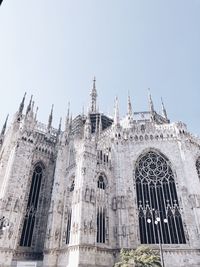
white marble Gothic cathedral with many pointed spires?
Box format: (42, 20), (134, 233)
(0, 79), (200, 267)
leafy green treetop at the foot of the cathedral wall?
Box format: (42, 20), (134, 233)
(114, 246), (161, 267)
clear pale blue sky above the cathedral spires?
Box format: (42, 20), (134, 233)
(0, 0), (200, 134)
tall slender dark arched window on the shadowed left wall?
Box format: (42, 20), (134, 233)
(20, 163), (44, 247)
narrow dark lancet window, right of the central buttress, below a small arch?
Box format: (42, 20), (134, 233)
(97, 207), (106, 243)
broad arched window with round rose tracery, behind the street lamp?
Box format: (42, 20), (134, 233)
(135, 151), (186, 244)
